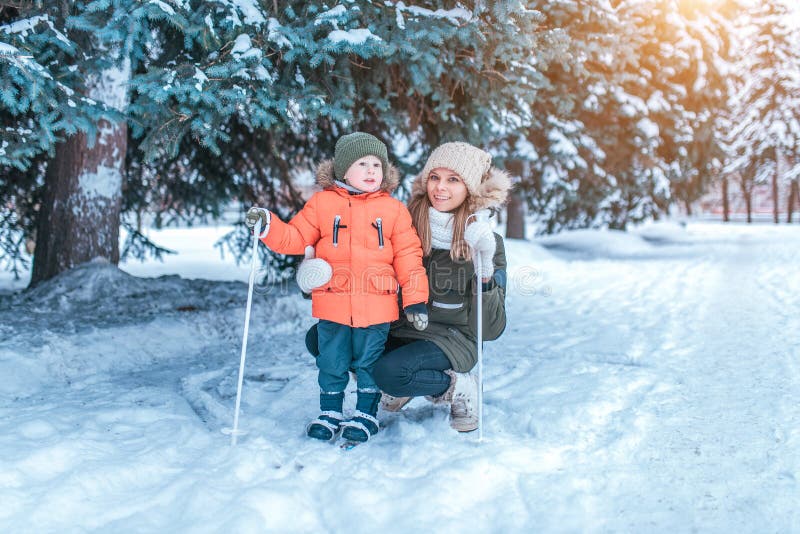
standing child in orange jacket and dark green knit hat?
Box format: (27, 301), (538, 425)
(246, 132), (428, 441)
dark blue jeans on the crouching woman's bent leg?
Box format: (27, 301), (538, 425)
(374, 338), (452, 397)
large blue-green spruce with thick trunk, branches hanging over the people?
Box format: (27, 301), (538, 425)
(0, 0), (552, 282)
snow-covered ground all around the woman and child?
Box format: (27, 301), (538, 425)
(0, 223), (800, 533)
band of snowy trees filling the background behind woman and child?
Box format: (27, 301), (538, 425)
(0, 0), (800, 285)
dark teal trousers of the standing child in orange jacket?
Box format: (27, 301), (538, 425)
(317, 320), (389, 393)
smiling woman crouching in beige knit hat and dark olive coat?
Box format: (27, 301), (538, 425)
(298, 143), (511, 432)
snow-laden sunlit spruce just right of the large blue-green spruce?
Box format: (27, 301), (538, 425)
(509, 0), (675, 232)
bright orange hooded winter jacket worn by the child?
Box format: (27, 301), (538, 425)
(262, 164), (428, 327)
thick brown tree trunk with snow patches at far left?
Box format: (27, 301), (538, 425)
(31, 61), (130, 286)
